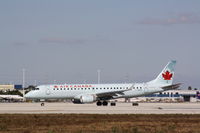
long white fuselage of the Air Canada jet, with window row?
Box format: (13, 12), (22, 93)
(25, 83), (164, 99)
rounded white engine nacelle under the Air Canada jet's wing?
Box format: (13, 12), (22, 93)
(73, 94), (96, 103)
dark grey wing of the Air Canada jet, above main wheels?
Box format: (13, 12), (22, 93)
(96, 89), (131, 99)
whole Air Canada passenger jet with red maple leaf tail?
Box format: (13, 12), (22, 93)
(25, 60), (181, 106)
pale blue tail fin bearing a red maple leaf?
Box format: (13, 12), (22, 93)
(149, 60), (176, 85)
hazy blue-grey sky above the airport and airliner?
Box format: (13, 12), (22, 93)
(0, 0), (200, 88)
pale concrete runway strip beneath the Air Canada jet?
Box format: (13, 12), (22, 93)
(0, 103), (200, 114)
